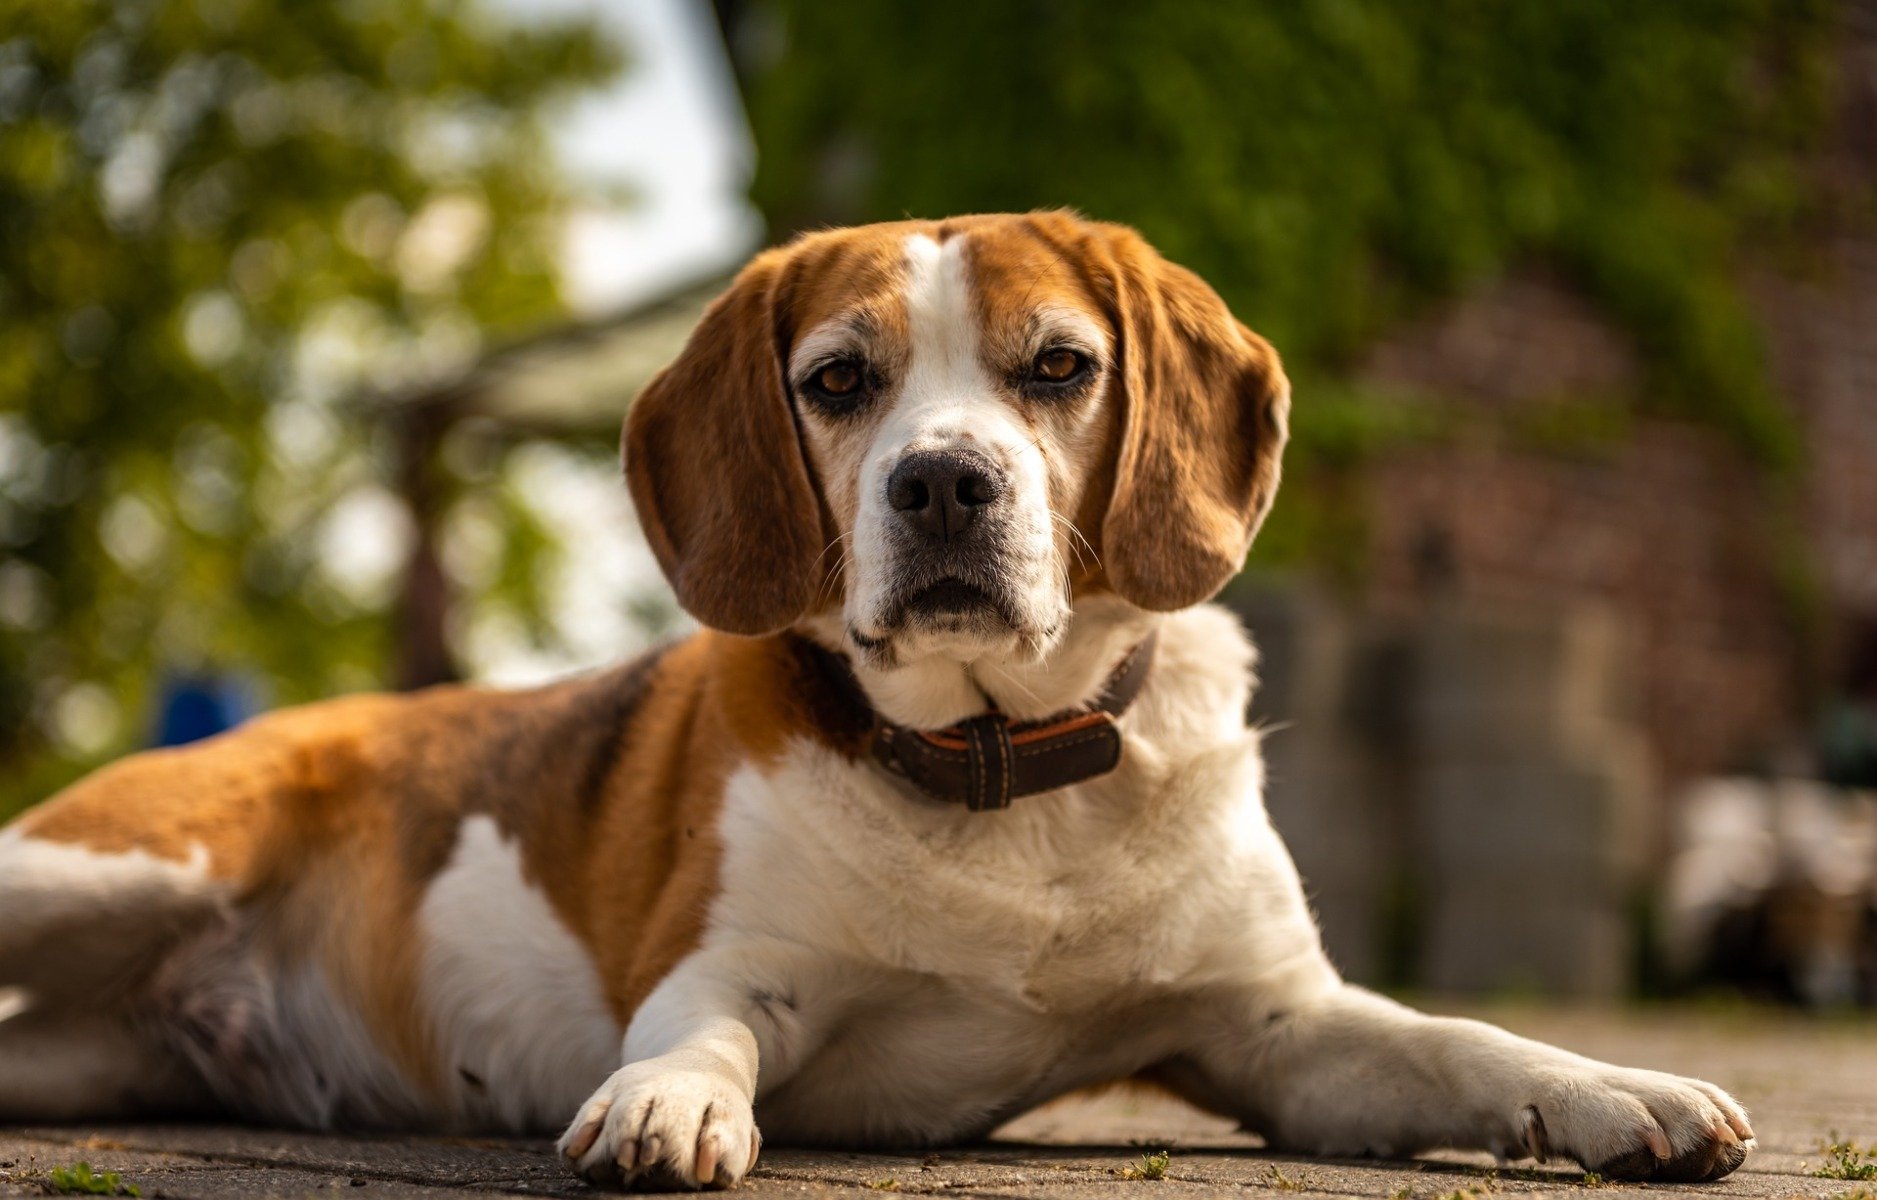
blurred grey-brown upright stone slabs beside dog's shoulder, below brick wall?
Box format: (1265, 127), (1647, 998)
(1235, 586), (1654, 997)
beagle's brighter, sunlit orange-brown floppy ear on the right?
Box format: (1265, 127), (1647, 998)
(1102, 225), (1289, 612)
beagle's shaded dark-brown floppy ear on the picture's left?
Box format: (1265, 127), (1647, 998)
(625, 252), (828, 635)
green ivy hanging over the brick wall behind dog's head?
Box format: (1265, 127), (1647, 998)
(717, 0), (1845, 478)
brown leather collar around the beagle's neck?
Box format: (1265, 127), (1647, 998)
(809, 635), (1154, 813)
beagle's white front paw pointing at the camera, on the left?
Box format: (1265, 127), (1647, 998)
(559, 1059), (762, 1191)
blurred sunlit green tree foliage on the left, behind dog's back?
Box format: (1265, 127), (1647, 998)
(0, 0), (618, 815)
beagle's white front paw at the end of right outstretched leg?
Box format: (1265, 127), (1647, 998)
(1517, 1067), (1753, 1183)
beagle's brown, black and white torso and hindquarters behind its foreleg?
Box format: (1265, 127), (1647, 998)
(0, 635), (760, 1131)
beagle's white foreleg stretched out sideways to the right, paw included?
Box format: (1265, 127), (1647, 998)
(1169, 986), (1753, 1181)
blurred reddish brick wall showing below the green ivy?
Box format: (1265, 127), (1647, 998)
(1363, 237), (1877, 787)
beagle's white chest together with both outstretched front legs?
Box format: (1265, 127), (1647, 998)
(563, 608), (1746, 1183)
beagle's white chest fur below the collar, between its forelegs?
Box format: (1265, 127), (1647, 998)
(683, 610), (1320, 1142)
